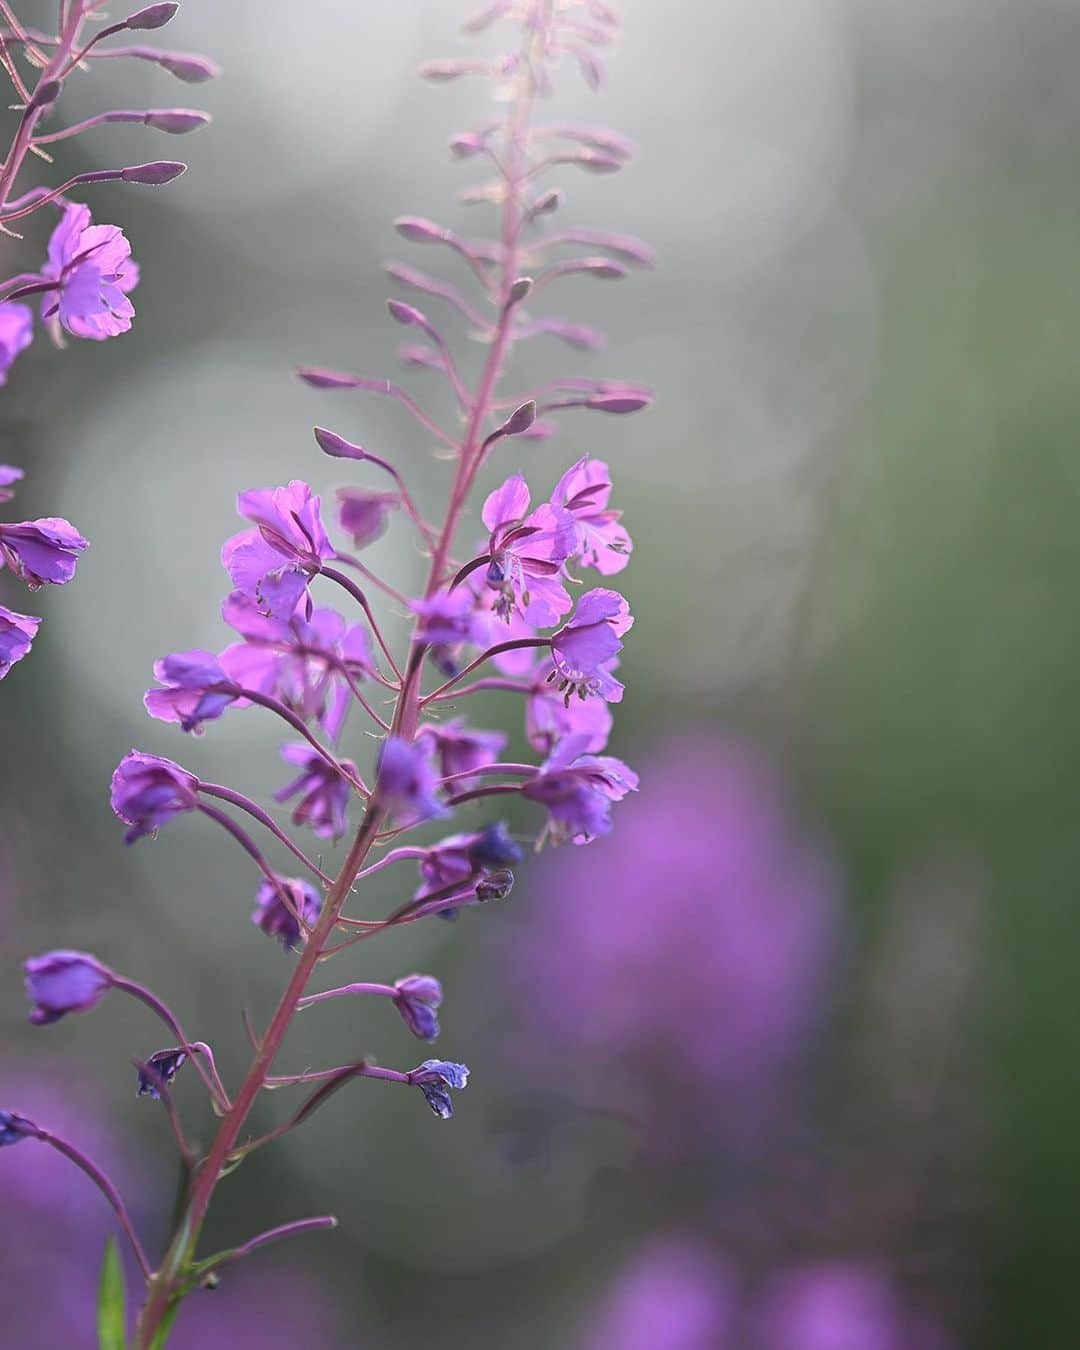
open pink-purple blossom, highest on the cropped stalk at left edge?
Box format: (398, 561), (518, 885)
(42, 204), (139, 342)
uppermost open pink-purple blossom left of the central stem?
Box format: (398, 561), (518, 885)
(221, 478), (333, 618)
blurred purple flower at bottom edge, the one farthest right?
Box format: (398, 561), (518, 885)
(755, 1261), (945, 1350)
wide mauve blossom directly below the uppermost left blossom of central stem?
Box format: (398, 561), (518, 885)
(217, 591), (374, 738)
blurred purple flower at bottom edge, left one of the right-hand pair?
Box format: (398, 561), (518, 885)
(581, 1238), (739, 1350)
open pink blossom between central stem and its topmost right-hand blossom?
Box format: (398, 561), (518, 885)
(482, 474), (576, 628)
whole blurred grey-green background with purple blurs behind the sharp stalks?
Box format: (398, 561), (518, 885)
(0, 0), (1080, 1350)
